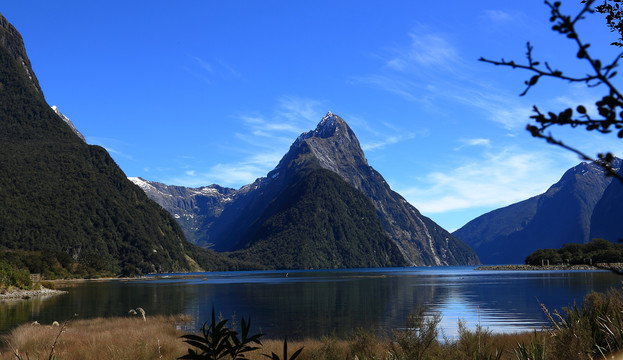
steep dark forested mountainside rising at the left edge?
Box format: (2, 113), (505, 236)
(0, 15), (201, 273)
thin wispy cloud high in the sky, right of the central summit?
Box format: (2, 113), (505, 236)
(352, 25), (544, 136)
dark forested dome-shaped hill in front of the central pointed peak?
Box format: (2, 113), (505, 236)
(232, 169), (406, 269)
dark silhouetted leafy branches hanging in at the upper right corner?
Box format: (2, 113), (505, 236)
(480, 0), (623, 181)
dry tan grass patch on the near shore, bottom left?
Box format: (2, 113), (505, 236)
(0, 316), (193, 360)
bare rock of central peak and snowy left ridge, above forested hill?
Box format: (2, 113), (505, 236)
(130, 112), (479, 265)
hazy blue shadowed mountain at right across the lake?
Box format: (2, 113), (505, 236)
(454, 159), (623, 264)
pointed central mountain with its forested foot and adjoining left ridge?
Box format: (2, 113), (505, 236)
(135, 112), (479, 268)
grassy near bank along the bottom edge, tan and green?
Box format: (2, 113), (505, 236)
(0, 289), (623, 360)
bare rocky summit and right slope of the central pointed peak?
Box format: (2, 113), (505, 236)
(278, 112), (478, 265)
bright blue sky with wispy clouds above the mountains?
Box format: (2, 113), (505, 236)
(0, 0), (623, 231)
